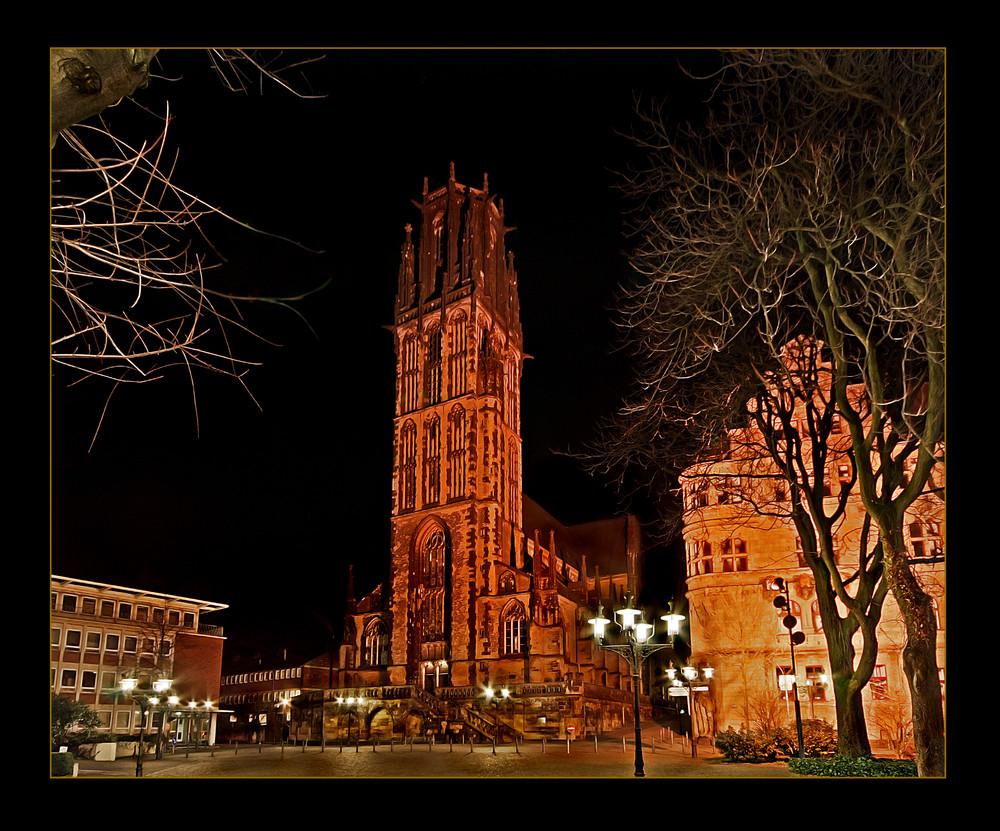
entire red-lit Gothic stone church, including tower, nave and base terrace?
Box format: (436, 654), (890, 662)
(294, 171), (664, 741)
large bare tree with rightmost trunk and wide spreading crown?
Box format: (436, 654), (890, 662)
(592, 49), (945, 776)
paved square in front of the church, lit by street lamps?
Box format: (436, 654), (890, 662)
(60, 724), (804, 781)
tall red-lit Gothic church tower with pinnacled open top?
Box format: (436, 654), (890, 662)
(388, 165), (525, 690)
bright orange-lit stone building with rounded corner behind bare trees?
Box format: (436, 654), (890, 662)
(682, 343), (945, 743)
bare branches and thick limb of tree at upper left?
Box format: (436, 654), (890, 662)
(50, 49), (324, 446)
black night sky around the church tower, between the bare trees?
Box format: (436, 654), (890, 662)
(51, 49), (716, 664)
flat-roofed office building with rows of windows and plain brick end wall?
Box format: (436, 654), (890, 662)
(50, 575), (226, 742)
